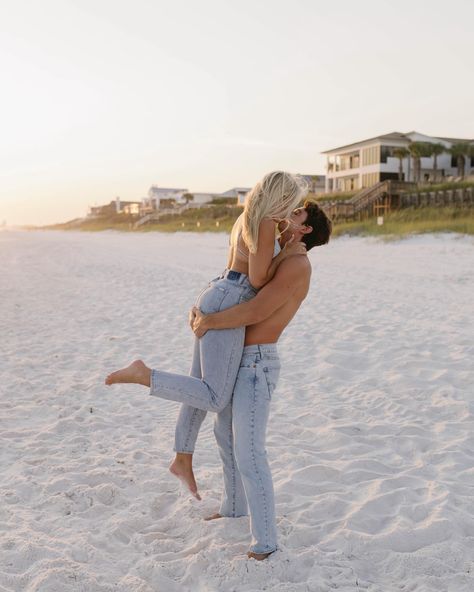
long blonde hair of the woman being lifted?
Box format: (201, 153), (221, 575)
(242, 171), (308, 253)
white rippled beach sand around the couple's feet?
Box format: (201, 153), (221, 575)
(0, 232), (474, 592)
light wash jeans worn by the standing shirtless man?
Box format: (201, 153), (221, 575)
(214, 344), (280, 553)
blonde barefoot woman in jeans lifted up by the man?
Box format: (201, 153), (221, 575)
(105, 171), (307, 499)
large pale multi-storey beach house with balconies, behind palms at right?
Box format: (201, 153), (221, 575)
(322, 132), (474, 193)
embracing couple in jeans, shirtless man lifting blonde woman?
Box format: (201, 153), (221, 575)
(105, 171), (331, 560)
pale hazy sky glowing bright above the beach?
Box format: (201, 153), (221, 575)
(0, 0), (474, 225)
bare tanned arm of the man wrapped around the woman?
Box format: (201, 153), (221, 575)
(192, 255), (311, 336)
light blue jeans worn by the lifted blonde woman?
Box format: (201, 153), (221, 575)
(150, 270), (257, 426)
